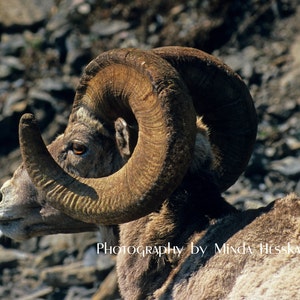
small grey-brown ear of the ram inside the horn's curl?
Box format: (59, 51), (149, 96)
(115, 118), (131, 159)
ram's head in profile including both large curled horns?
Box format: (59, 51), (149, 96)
(0, 47), (256, 239)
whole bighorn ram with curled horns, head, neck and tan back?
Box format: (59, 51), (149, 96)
(0, 47), (300, 299)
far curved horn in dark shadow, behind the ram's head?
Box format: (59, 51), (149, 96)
(152, 46), (257, 191)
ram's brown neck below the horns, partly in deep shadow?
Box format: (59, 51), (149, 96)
(117, 172), (236, 299)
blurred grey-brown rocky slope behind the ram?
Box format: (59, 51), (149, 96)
(0, 0), (300, 300)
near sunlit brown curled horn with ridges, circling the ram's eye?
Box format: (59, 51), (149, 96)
(19, 49), (196, 224)
